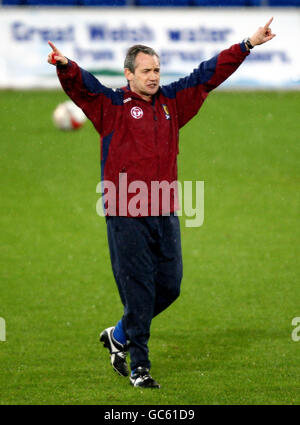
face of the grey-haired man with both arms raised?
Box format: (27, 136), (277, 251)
(125, 52), (160, 101)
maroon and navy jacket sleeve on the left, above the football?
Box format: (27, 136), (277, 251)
(57, 60), (116, 134)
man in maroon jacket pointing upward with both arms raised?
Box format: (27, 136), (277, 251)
(48, 18), (275, 388)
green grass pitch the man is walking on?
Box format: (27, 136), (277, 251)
(0, 91), (300, 405)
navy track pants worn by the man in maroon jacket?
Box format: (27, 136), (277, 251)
(106, 214), (182, 370)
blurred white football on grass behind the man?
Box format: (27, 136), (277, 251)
(53, 100), (86, 130)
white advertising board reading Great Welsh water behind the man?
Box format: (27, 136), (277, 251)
(0, 8), (300, 89)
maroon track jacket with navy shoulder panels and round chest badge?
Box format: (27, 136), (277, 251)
(57, 43), (249, 216)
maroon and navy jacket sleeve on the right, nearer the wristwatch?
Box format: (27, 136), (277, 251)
(163, 43), (249, 128)
